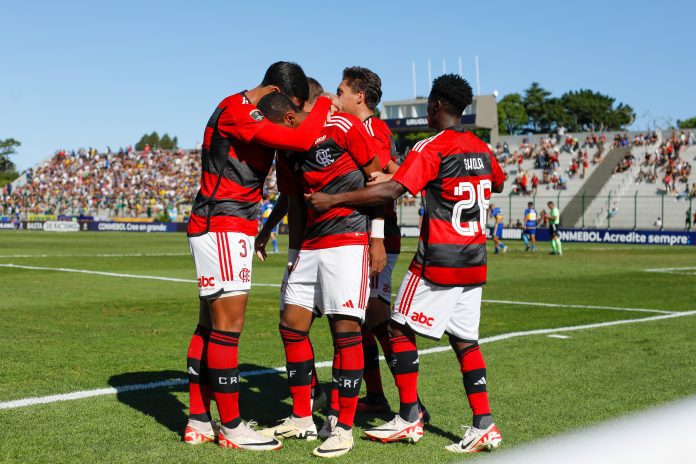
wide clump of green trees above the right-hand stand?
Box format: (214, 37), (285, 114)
(498, 82), (636, 134)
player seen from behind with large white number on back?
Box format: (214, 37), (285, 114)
(308, 74), (504, 453)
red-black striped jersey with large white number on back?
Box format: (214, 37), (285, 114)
(392, 129), (505, 286)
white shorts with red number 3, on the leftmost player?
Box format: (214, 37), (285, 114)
(189, 232), (254, 299)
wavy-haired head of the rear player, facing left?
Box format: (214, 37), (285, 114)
(336, 66), (382, 115)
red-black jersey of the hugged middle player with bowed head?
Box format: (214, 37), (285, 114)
(278, 113), (374, 250)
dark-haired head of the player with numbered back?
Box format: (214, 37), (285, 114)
(428, 74), (474, 130)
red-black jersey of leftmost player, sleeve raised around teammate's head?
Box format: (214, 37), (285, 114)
(188, 92), (331, 236)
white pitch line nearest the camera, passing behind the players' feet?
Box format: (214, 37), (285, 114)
(0, 311), (696, 409)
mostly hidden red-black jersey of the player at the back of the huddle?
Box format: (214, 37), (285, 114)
(363, 116), (401, 253)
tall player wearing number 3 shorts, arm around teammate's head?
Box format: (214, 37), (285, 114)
(185, 62), (337, 450)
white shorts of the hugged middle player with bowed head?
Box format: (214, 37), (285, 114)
(281, 245), (370, 321)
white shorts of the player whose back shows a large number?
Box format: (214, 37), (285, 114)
(392, 271), (482, 341)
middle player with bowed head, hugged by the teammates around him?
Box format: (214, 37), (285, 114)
(259, 89), (383, 457)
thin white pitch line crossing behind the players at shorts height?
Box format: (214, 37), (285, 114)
(0, 263), (674, 314)
